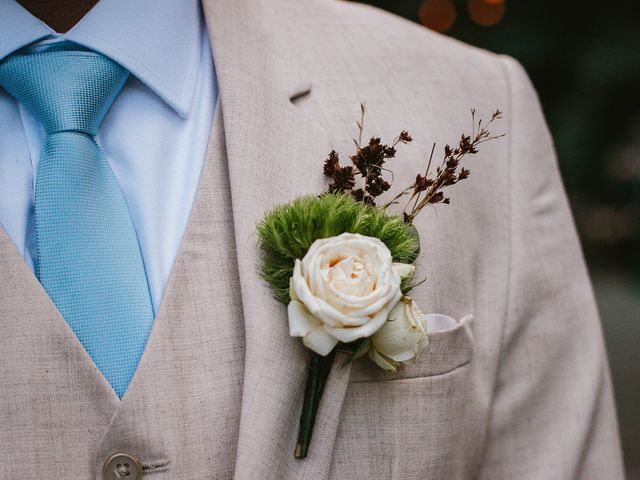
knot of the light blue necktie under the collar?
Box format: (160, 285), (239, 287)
(0, 50), (129, 136)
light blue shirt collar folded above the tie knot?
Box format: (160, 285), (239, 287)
(0, 0), (204, 117)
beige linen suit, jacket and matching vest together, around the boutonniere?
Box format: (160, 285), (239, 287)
(0, 0), (623, 480)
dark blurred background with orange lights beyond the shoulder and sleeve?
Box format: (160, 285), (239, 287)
(356, 0), (640, 480)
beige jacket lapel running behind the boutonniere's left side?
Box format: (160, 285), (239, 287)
(203, 0), (350, 479)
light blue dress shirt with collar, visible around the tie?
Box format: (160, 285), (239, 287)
(0, 0), (218, 312)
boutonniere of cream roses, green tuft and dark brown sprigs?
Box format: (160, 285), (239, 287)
(258, 104), (502, 458)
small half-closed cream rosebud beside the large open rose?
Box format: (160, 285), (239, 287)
(369, 297), (430, 372)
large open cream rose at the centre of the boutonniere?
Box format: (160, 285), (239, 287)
(288, 233), (415, 355)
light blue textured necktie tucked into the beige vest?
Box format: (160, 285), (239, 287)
(0, 50), (154, 398)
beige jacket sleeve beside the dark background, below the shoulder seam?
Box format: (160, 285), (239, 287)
(479, 57), (624, 480)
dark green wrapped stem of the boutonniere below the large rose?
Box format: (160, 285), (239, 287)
(294, 350), (335, 458)
